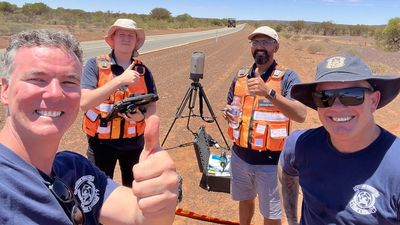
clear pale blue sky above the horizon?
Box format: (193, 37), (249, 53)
(5, 0), (400, 25)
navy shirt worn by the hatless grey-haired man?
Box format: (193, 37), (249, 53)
(0, 144), (118, 225)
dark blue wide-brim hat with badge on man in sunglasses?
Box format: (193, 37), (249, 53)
(290, 55), (400, 110)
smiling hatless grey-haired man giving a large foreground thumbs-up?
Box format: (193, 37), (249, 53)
(0, 30), (178, 225)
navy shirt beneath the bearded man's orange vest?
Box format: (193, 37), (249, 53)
(227, 61), (300, 165)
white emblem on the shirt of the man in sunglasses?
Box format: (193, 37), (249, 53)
(349, 184), (379, 215)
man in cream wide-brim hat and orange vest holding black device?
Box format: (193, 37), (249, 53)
(81, 19), (157, 186)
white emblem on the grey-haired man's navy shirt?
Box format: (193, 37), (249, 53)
(74, 175), (100, 213)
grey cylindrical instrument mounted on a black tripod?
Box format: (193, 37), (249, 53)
(161, 52), (229, 149)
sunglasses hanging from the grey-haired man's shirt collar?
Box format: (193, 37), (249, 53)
(48, 177), (85, 225)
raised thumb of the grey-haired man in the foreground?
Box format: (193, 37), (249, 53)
(139, 115), (161, 161)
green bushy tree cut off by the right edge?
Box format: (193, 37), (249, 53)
(382, 17), (400, 51)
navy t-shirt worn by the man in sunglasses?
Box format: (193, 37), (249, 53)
(280, 127), (400, 225)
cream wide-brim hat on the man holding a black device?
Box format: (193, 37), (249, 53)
(104, 19), (145, 56)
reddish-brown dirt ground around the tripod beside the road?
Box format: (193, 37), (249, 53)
(0, 27), (400, 225)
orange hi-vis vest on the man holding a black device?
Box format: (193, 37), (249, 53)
(83, 55), (148, 139)
